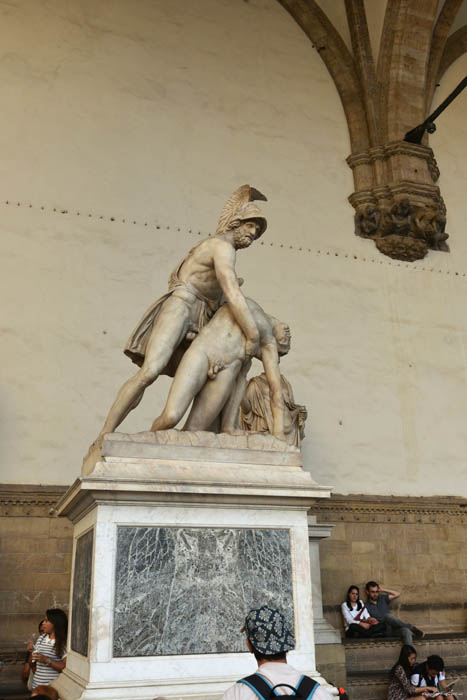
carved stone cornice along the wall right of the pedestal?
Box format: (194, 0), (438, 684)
(310, 494), (467, 524)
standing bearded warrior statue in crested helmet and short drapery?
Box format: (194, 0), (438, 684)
(93, 185), (267, 445)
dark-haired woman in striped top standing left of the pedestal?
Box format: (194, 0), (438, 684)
(32, 608), (68, 689)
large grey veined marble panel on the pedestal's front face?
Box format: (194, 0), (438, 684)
(113, 527), (294, 657)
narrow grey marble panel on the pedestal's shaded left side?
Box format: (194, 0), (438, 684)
(71, 530), (94, 656)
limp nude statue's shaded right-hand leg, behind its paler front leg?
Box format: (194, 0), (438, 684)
(183, 360), (243, 430)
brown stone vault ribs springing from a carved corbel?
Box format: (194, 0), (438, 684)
(279, 0), (467, 260)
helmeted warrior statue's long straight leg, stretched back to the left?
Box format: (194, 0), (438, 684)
(99, 297), (189, 437)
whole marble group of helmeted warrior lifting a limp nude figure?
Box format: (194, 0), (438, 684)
(93, 185), (306, 454)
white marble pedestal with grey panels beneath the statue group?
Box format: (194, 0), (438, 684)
(55, 431), (330, 700)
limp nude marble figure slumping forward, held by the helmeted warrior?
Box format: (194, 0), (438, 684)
(151, 299), (290, 440)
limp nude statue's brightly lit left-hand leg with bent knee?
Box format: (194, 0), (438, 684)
(151, 344), (209, 433)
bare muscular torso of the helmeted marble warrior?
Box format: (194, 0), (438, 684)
(178, 238), (235, 302)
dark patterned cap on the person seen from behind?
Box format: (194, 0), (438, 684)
(243, 605), (295, 656)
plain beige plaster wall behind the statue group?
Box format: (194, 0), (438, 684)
(0, 0), (467, 495)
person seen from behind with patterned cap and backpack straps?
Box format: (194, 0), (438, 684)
(222, 605), (331, 700)
